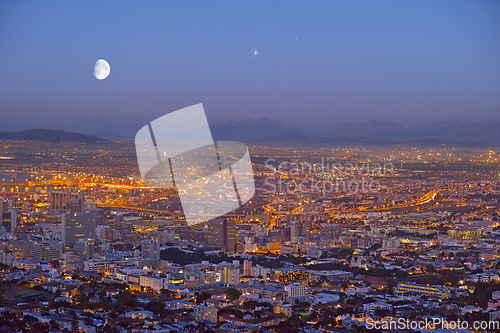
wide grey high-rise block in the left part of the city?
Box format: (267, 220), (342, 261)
(61, 212), (97, 250)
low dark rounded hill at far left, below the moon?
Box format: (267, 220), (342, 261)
(0, 128), (106, 143)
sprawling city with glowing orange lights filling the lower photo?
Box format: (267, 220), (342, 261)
(0, 140), (500, 332)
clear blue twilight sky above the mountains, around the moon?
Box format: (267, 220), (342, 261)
(0, 0), (500, 125)
